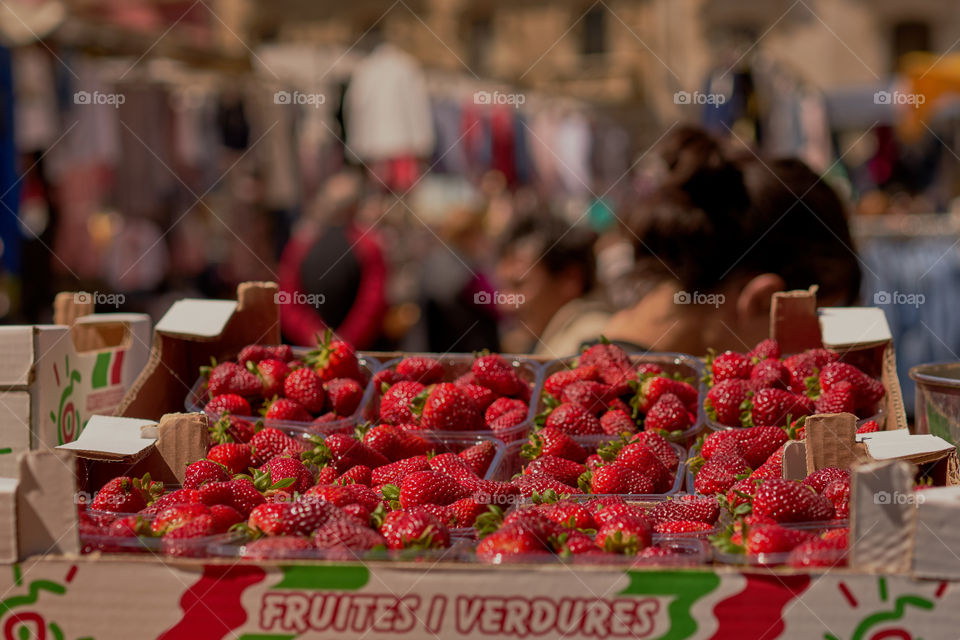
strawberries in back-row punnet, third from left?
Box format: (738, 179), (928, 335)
(538, 343), (699, 437)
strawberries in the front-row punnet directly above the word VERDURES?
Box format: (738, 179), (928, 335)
(476, 493), (719, 562)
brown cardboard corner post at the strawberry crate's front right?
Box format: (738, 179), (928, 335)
(850, 461), (917, 573)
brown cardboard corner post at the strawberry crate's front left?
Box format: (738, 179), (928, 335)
(16, 450), (80, 558)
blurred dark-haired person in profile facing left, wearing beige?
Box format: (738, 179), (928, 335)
(497, 213), (610, 358)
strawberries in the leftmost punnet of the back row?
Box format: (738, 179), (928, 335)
(201, 332), (367, 424)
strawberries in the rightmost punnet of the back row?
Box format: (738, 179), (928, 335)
(704, 339), (884, 427)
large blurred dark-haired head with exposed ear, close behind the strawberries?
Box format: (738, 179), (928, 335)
(600, 128), (860, 354)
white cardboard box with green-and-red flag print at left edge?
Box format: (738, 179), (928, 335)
(0, 293), (150, 476)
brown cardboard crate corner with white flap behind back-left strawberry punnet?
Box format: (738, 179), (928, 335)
(116, 282), (280, 420)
